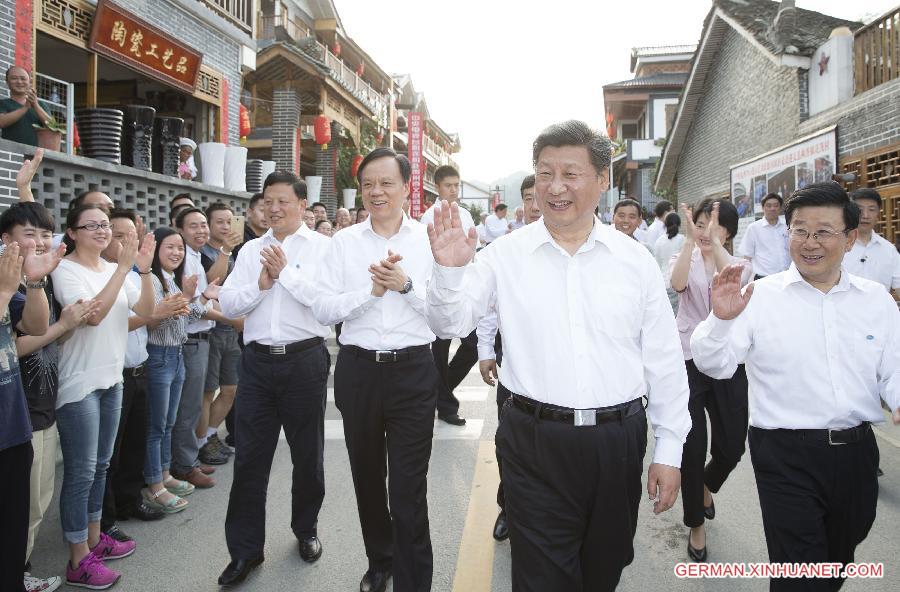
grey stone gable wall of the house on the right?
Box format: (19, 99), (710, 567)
(677, 29), (800, 203)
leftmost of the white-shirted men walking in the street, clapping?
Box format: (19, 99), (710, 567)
(219, 172), (331, 586)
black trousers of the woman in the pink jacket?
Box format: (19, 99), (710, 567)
(681, 360), (747, 528)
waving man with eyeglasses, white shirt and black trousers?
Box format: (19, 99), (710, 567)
(691, 182), (900, 591)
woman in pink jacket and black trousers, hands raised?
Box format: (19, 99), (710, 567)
(668, 199), (753, 562)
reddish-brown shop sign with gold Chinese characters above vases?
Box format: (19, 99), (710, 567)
(90, 0), (203, 92)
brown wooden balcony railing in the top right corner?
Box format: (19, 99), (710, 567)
(853, 7), (900, 94)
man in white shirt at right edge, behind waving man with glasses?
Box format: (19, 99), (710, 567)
(844, 187), (900, 301)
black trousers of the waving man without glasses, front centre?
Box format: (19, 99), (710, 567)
(497, 398), (647, 592)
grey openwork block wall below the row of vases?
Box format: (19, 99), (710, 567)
(0, 140), (251, 229)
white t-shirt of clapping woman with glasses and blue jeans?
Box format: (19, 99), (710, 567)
(51, 259), (141, 409)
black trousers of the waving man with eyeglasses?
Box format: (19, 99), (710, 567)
(749, 427), (879, 592)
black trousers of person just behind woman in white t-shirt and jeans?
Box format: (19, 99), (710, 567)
(100, 368), (147, 530)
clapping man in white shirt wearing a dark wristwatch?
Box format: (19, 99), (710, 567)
(313, 148), (442, 592)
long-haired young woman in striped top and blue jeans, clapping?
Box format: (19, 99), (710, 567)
(141, 228), (216, 514)
